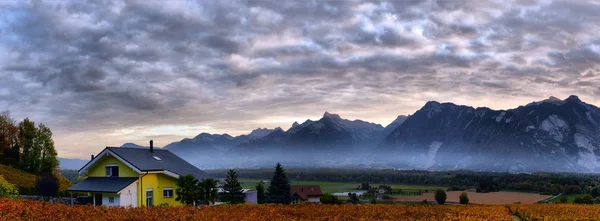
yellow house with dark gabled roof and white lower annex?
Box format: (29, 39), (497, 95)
(67, 141), (206, 207)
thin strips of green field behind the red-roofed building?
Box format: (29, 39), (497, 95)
(240, 179), (446, 193)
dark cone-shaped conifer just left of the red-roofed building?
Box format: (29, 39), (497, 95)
(267, 163), (292, 204)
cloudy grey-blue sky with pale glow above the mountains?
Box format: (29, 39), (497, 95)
(0, 0), (600, 159)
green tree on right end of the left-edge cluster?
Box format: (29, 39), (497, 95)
(36, 124), (58, 173)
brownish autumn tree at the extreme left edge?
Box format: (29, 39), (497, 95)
(0, 112), (20, 167)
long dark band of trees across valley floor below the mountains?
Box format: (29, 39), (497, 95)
(216, 169), (600, 195)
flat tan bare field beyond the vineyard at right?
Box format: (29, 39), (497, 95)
(392, 191), (552, 204)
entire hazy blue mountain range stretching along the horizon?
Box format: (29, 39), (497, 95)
(59, 96), (600, 172)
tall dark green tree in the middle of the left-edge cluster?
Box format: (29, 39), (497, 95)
(19, 118), (42, 173)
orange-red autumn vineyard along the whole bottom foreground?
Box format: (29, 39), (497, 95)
(0, 199), (600, 221)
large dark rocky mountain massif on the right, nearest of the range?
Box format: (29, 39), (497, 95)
(380, 96), (600, 172)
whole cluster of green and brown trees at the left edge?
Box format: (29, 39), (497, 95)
(0, 112), (58, 174)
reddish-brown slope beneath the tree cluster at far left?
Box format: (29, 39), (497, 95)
(0, 165), (72, 195)
